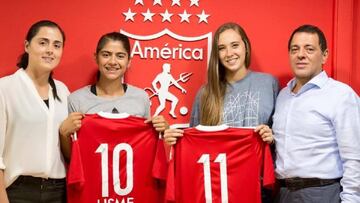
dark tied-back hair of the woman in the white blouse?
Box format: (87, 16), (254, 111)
(16, 20), (65, 101)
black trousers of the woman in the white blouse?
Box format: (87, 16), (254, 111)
(6, 176), (66, 203)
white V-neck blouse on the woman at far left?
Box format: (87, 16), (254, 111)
(0, 69), (69, 187)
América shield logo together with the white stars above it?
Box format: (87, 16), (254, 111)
(120, 0), (212, 127)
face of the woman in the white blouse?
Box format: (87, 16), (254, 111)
(25, 27), (63, 72)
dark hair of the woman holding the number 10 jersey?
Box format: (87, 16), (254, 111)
(95, 32), (131, 80)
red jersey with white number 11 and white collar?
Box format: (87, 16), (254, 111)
(167, 126), (275, 203)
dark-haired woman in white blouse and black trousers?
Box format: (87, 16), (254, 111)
(0, 20), (74, 203)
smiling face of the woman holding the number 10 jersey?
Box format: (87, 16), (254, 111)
(96, 40), (130, 81)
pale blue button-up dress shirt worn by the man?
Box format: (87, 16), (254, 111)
(273, 71), (360, 202)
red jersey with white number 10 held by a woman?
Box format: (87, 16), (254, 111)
(67, 114), (166, 203)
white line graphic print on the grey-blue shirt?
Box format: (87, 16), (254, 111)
(224, 91), (260, 126)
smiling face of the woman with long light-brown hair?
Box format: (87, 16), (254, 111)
(218, 29), (246, 81)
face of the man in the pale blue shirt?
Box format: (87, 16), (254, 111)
(289, 32), (328, 84)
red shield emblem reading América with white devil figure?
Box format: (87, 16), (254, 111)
(120, 29), (212, 127)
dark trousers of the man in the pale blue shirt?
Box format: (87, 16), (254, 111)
(275, 182), (341, 203)
